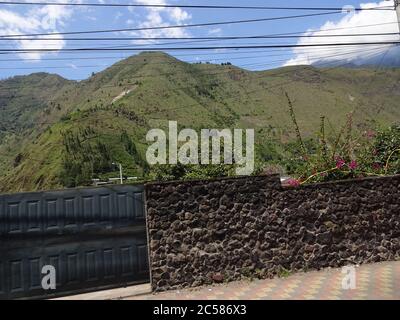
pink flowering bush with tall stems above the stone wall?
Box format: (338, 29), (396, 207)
(285, 95), (400, 187)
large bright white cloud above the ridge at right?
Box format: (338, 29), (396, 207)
(284, 1), (399, 66)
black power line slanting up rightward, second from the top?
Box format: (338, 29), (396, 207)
(0, 11), (343, 38)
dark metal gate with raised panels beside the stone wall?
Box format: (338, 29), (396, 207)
(0, 186), (149, 299)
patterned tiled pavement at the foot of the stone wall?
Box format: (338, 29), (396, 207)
(127, 261), (400, 300)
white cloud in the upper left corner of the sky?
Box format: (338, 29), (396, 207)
(0, 0), (80, 59)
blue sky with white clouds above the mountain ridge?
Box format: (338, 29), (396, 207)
(0, 0), (398, 79)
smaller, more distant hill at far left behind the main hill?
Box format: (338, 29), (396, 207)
(0, 73), (73, 180)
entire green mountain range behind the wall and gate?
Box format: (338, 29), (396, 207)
(0, 52), (400, 192)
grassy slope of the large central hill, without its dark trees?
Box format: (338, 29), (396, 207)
(0, 53), (400, 191)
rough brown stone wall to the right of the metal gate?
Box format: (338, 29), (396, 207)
(146, 175), (400, 291)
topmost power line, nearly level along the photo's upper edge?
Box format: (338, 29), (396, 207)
(0, 1), (393, 11)
